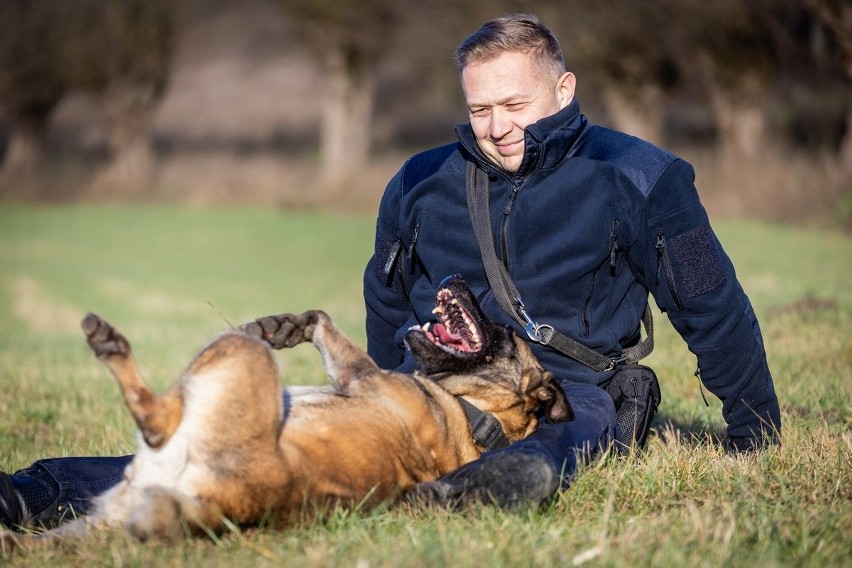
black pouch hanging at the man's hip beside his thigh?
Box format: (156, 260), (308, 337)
(603, 363), (661, 453)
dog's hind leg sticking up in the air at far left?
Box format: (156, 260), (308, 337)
(80, 313), (183, 448)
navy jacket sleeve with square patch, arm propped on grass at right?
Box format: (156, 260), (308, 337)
(631, 160), (781, 440)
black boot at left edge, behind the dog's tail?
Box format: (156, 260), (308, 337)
(0, 465), (67, 529)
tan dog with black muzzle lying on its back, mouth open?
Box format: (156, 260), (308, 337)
(0, 276), (573, 549)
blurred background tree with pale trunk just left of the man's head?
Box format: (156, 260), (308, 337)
(275, 0), (559, 186)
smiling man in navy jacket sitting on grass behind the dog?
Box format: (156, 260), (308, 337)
(0, 15), (781, 526)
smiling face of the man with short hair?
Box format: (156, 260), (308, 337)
(462, 52), (574, 172)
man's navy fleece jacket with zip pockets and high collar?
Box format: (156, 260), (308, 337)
(364, 101), (781, 437)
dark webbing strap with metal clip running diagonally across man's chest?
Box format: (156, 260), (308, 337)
(466, 162), (654, 371)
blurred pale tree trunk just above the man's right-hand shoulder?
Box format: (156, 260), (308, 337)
(604, 84), (665, 146)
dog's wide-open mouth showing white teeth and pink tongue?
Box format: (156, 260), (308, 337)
(420, 288), (482, 353)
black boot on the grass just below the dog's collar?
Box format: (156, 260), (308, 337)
(407, 451), (559, 510)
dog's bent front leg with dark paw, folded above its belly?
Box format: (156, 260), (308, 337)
(241, 310), (380, 392)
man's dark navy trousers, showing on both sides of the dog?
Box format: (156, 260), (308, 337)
(18, 381), (617, 515)
